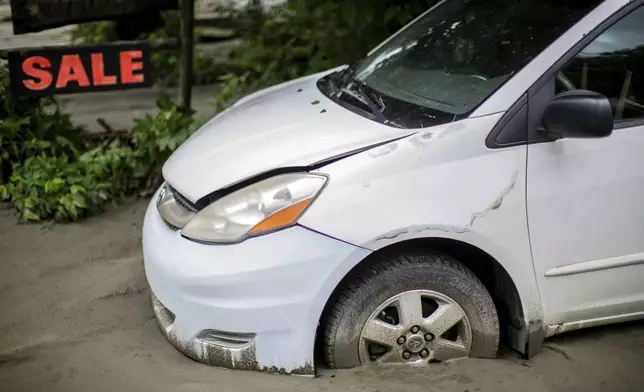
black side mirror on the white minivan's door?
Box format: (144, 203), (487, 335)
(543, 90), (613, 139)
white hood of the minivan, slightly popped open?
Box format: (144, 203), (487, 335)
(163, 69), (415, 202)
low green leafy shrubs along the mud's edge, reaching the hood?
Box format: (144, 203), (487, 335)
(0, 95), (204, 222)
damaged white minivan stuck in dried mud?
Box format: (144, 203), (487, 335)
(143, 0), (644, 375)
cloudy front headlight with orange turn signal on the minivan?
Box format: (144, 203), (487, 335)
(181, 173), (326, 243)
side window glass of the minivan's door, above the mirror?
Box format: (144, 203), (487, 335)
(556, 7), (644, 123)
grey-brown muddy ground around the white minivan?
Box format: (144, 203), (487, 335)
(0, 201), (644, 392)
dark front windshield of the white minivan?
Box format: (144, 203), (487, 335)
(328, 0), (601, 127)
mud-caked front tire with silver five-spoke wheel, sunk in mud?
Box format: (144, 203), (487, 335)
(323, 252), (499, 368)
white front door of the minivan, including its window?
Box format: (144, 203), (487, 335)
(526, 7), (644, 327)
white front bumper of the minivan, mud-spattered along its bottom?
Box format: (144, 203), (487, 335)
(143, 197), (369, 375)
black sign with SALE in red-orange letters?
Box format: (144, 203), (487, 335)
(9, 43), (153, 96)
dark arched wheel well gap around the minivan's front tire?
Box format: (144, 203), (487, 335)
(316, 238), (523, 362)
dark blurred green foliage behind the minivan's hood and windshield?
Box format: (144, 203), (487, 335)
(216, 0), (438, 105)
